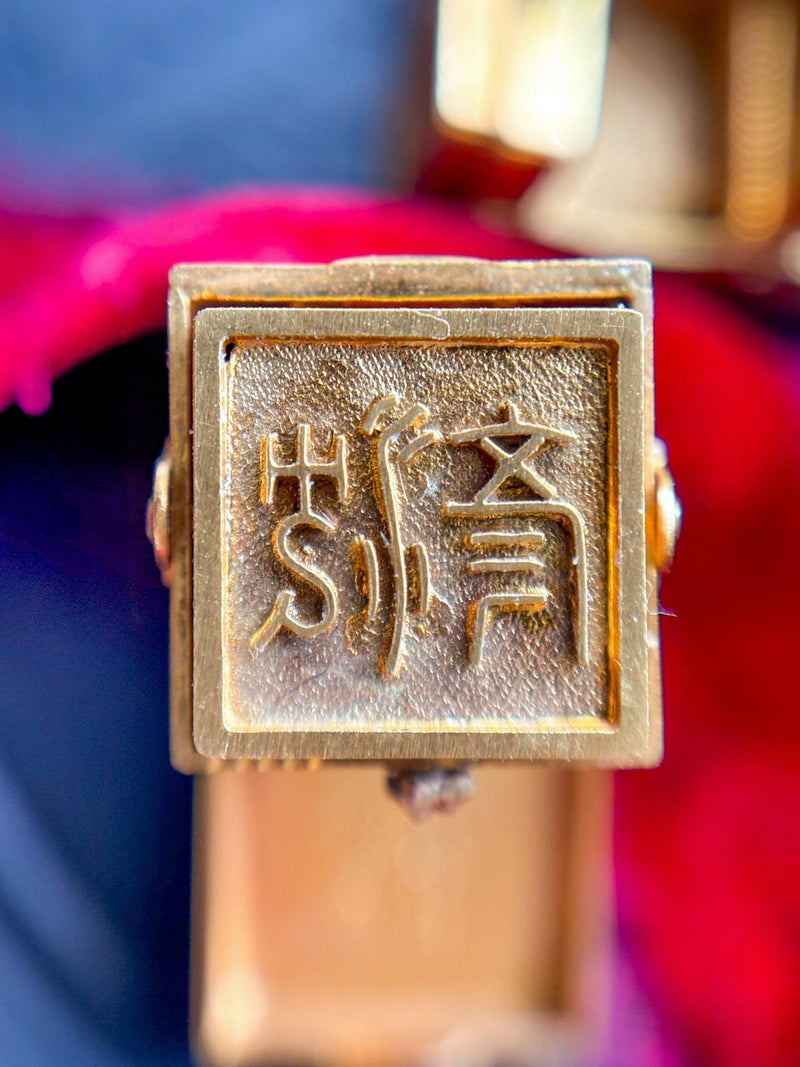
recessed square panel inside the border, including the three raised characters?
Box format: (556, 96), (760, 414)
(221, 340), (613, 731)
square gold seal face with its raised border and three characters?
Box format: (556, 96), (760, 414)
(193, 307), (657, 764)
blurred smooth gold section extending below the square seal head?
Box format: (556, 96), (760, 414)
(192, 765), (613, 1067)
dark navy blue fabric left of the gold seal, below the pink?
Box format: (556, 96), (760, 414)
(0, 337), (191, 1067)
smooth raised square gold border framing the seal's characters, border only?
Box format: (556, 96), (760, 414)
(193, 308), (652, 764)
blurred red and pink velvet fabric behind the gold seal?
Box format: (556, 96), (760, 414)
(0, 191), (800, 1067)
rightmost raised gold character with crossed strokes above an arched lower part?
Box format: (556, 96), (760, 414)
(443, 403), (588, 667)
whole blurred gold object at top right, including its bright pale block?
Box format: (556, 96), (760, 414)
(434, 0), (800, 282)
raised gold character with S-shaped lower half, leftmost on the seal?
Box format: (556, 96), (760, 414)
(251, 423), (348, 650)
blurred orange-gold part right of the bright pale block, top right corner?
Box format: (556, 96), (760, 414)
(519, 0), (800, 276)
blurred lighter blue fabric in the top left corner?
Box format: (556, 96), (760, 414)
(0, 0), (430, 208)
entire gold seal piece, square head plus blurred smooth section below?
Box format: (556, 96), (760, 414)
(148, 258), (679, 1067)
